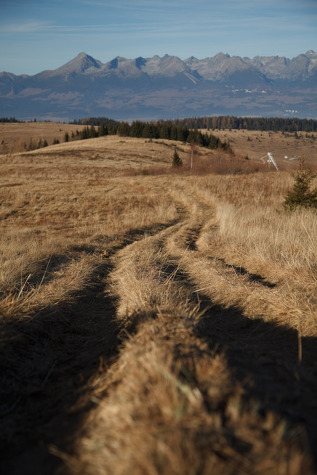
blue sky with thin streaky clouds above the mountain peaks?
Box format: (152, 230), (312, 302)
(0, 0), (317, 74)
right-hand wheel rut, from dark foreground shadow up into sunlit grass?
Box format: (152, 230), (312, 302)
(165, 184), (317, 470)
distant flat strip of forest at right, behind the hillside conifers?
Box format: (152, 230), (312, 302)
(168, 116), (317, 132)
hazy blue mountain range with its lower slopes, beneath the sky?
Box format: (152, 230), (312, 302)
(0, 51), (317, 120)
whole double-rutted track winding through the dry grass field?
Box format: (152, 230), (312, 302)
(1, 180), (317, 475)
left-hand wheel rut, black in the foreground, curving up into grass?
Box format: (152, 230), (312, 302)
(0, 210), (188, 475)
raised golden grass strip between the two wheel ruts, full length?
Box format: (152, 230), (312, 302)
(64, 183), (313, 475)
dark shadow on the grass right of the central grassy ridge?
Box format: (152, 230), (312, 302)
(196, 297), (317, 467)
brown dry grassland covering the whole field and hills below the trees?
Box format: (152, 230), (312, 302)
(0, 123), (317, 475)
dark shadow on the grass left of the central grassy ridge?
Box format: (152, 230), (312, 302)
(0, 258), (118, 475)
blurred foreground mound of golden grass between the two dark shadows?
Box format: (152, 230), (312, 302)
(65, 309), (310, 475)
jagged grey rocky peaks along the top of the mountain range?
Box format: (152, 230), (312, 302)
(30, 50), (317, 81)
